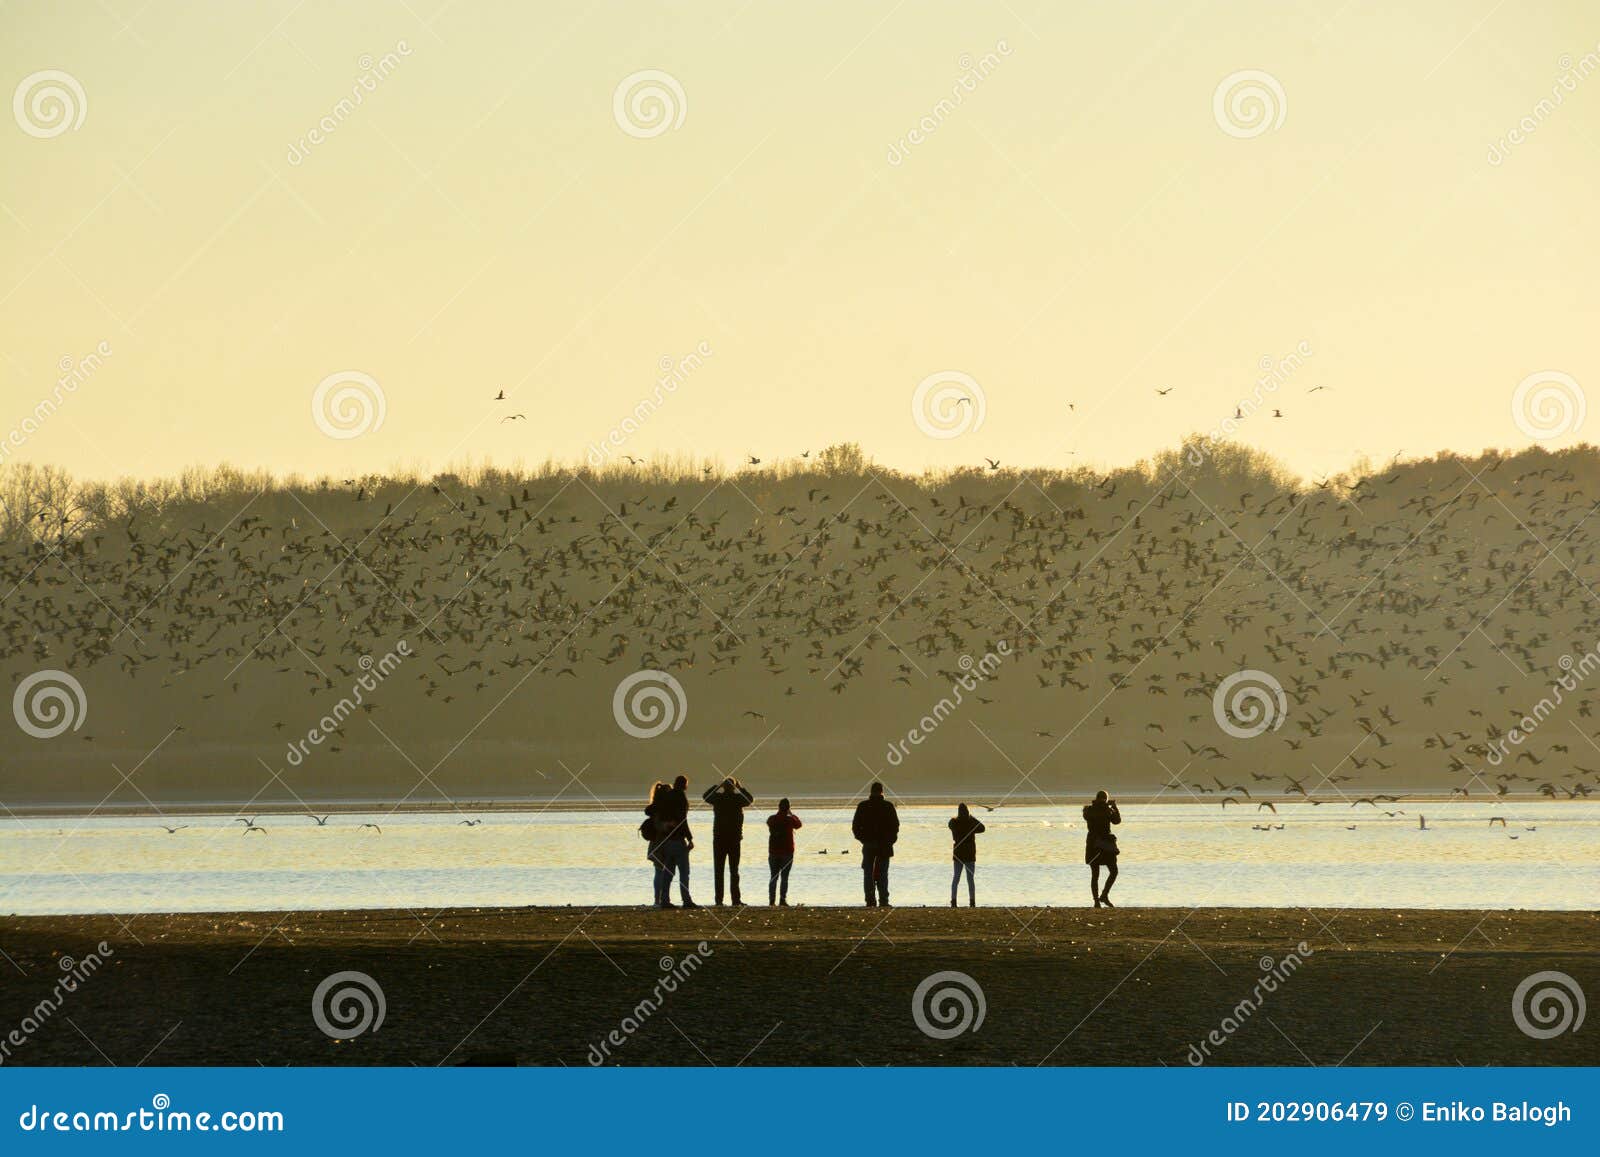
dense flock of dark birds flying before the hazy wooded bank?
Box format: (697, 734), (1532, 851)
(0, 435), (1600, 834)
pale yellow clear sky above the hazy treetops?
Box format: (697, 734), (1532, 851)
(0, 0), (1600, 477)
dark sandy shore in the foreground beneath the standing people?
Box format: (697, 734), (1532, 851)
(0, 907), (1600, 1066)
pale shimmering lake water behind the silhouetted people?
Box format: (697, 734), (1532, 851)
(0, 800), (1600, 915)
